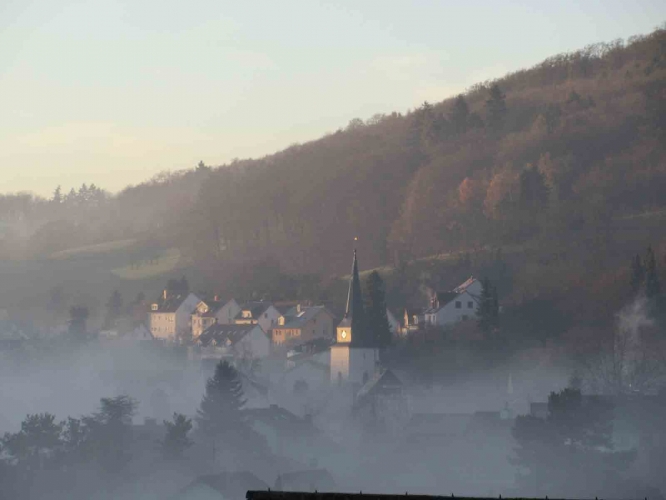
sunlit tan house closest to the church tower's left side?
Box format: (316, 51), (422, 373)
(272, 304), (333, 346)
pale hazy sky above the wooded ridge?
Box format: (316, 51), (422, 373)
(0, 0), (666, 196)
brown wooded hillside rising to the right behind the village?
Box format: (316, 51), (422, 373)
(0, 28), (666, 324)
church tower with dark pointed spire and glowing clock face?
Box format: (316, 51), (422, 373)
(331, 250), (379, 387)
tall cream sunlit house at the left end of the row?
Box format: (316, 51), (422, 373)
(150, 290), (201, 340)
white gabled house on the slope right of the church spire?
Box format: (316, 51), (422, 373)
(425, 278), (482, 326)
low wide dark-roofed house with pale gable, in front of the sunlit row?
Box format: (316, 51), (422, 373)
(196, 323), (271, 361)
